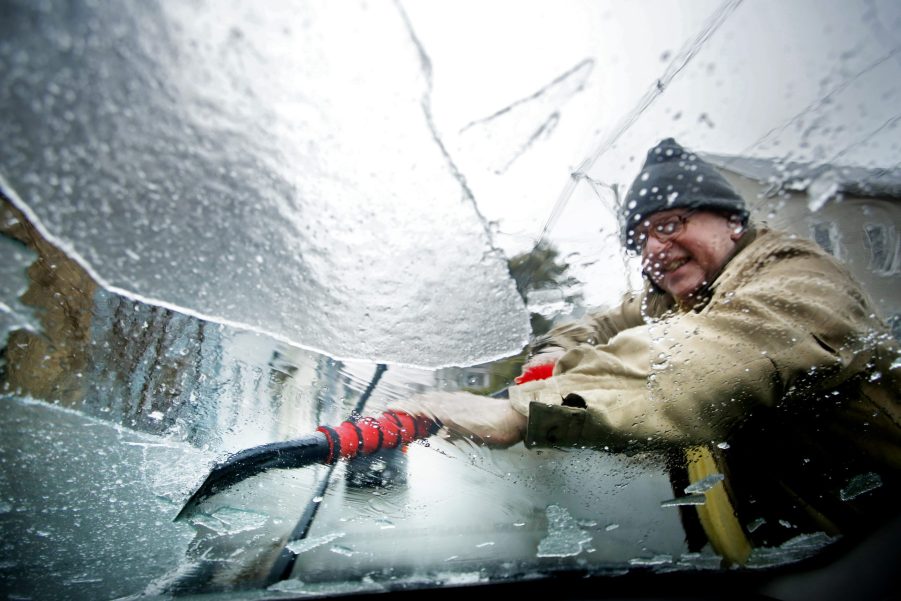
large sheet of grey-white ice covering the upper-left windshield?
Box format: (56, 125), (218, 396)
(0, 2), (528, 367)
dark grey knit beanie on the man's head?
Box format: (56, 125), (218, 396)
(620, 138), (748, 250)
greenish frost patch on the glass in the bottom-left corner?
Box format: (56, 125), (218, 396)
(0, 399), (205, 599)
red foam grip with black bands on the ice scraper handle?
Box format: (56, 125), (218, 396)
(316, 411), (438, 463)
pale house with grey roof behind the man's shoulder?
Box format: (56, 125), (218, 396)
(702, 154), (901, 339)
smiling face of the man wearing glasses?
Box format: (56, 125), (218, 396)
(639, 209), (743, 304)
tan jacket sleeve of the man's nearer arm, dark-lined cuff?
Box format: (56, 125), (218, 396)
(510, 238), (875, 451)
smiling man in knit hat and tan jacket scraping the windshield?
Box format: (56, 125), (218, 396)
(390, 139), (901, 563)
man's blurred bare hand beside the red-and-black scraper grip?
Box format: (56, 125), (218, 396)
(388, 392), (526, 448)
